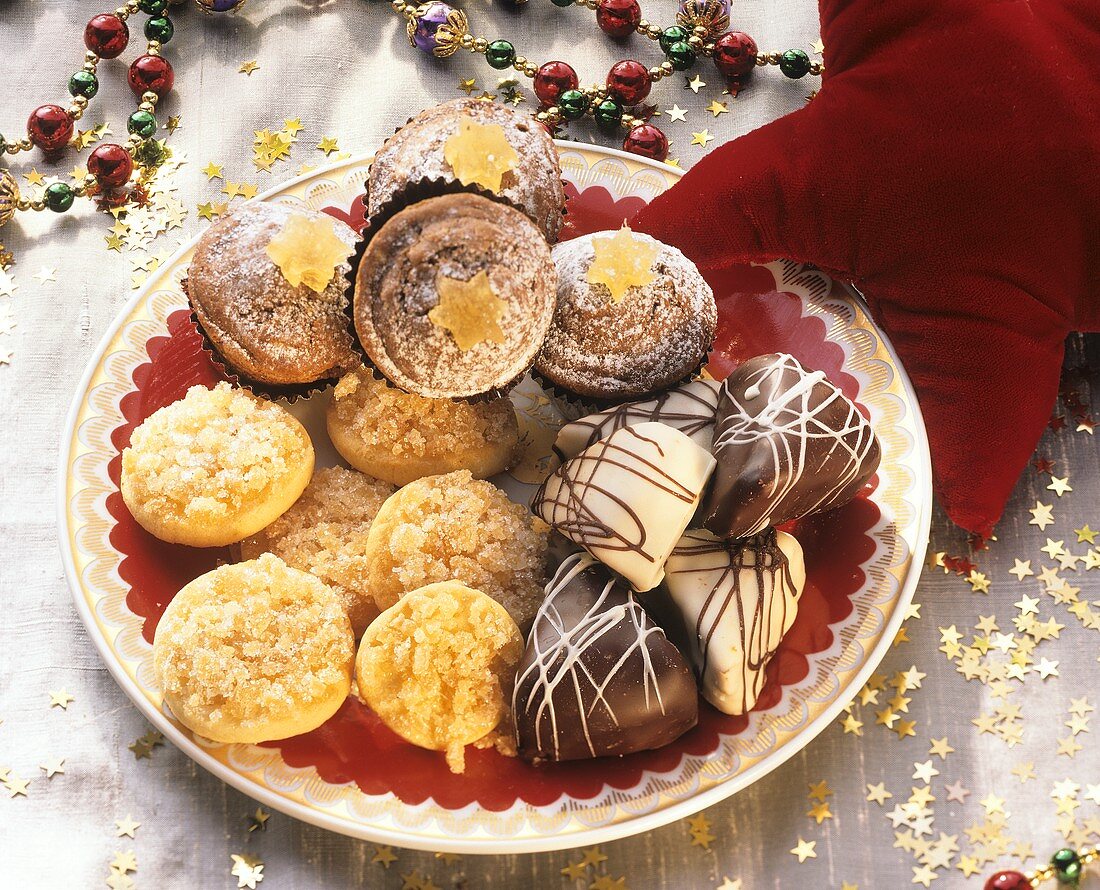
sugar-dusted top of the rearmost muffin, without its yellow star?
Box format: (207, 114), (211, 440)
(366, 98), (565, 242)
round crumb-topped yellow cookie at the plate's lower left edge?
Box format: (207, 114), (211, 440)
(153, 553), (355, 743)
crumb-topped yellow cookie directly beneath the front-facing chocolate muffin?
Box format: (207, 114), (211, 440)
(333, 370), (517, 460)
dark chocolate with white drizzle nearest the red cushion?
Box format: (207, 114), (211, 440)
(696, 353), (881, 538)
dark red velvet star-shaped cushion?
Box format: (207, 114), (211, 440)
(631, 0), (1100, 534)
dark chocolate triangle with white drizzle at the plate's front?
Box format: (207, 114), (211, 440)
(512, 553), (699, 760)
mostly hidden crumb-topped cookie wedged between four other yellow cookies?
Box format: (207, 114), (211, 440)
(241, 466), (395, 636)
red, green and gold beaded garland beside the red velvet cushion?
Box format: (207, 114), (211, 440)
(391, 0), (824, 161)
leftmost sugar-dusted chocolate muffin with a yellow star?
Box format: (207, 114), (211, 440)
(185, 202), (359, 386)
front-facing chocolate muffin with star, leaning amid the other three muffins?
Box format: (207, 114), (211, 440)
(354, 194), (556, 398)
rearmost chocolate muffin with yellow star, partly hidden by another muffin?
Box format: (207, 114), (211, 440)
(366, 98), (565, 242)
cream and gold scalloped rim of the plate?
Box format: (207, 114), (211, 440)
(57, 142), (932, 854)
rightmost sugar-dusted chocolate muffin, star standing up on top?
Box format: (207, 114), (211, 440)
(535, 228), (718, 406)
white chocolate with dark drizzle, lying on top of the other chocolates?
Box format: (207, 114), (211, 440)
(531, 424), (714, 592)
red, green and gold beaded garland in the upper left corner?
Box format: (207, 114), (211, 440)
(0, 0), (243, 234)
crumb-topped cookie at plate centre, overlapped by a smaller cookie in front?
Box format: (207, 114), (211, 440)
(366, 470), (547, 633)
